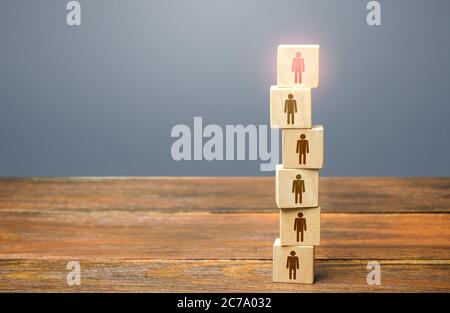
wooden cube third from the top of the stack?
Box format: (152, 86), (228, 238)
(282, 125), (323, 169)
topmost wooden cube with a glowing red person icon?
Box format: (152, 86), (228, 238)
(277, 45), (319, 88)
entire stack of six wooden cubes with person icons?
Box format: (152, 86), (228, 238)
(270, 45), (323, 284)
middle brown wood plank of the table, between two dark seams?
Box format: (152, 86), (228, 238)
(0, 210), (450, 260)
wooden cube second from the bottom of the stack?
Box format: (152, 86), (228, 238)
(280, 207), (320, 246)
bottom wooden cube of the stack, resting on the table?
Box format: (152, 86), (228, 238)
(273, 238), (314, 284)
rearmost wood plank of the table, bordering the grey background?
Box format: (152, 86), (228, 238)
(0, 177), (450, 213)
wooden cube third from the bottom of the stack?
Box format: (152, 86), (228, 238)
(275, 164), (319, 209)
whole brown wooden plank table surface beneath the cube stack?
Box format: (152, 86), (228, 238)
(0, 177), (450, 292)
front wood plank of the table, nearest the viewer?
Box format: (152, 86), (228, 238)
(0, 260), (450, 292)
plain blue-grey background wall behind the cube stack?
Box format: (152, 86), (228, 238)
(0, 0), (450, 176)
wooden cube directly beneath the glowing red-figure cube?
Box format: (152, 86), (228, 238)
(270, 86), (311, 128)
